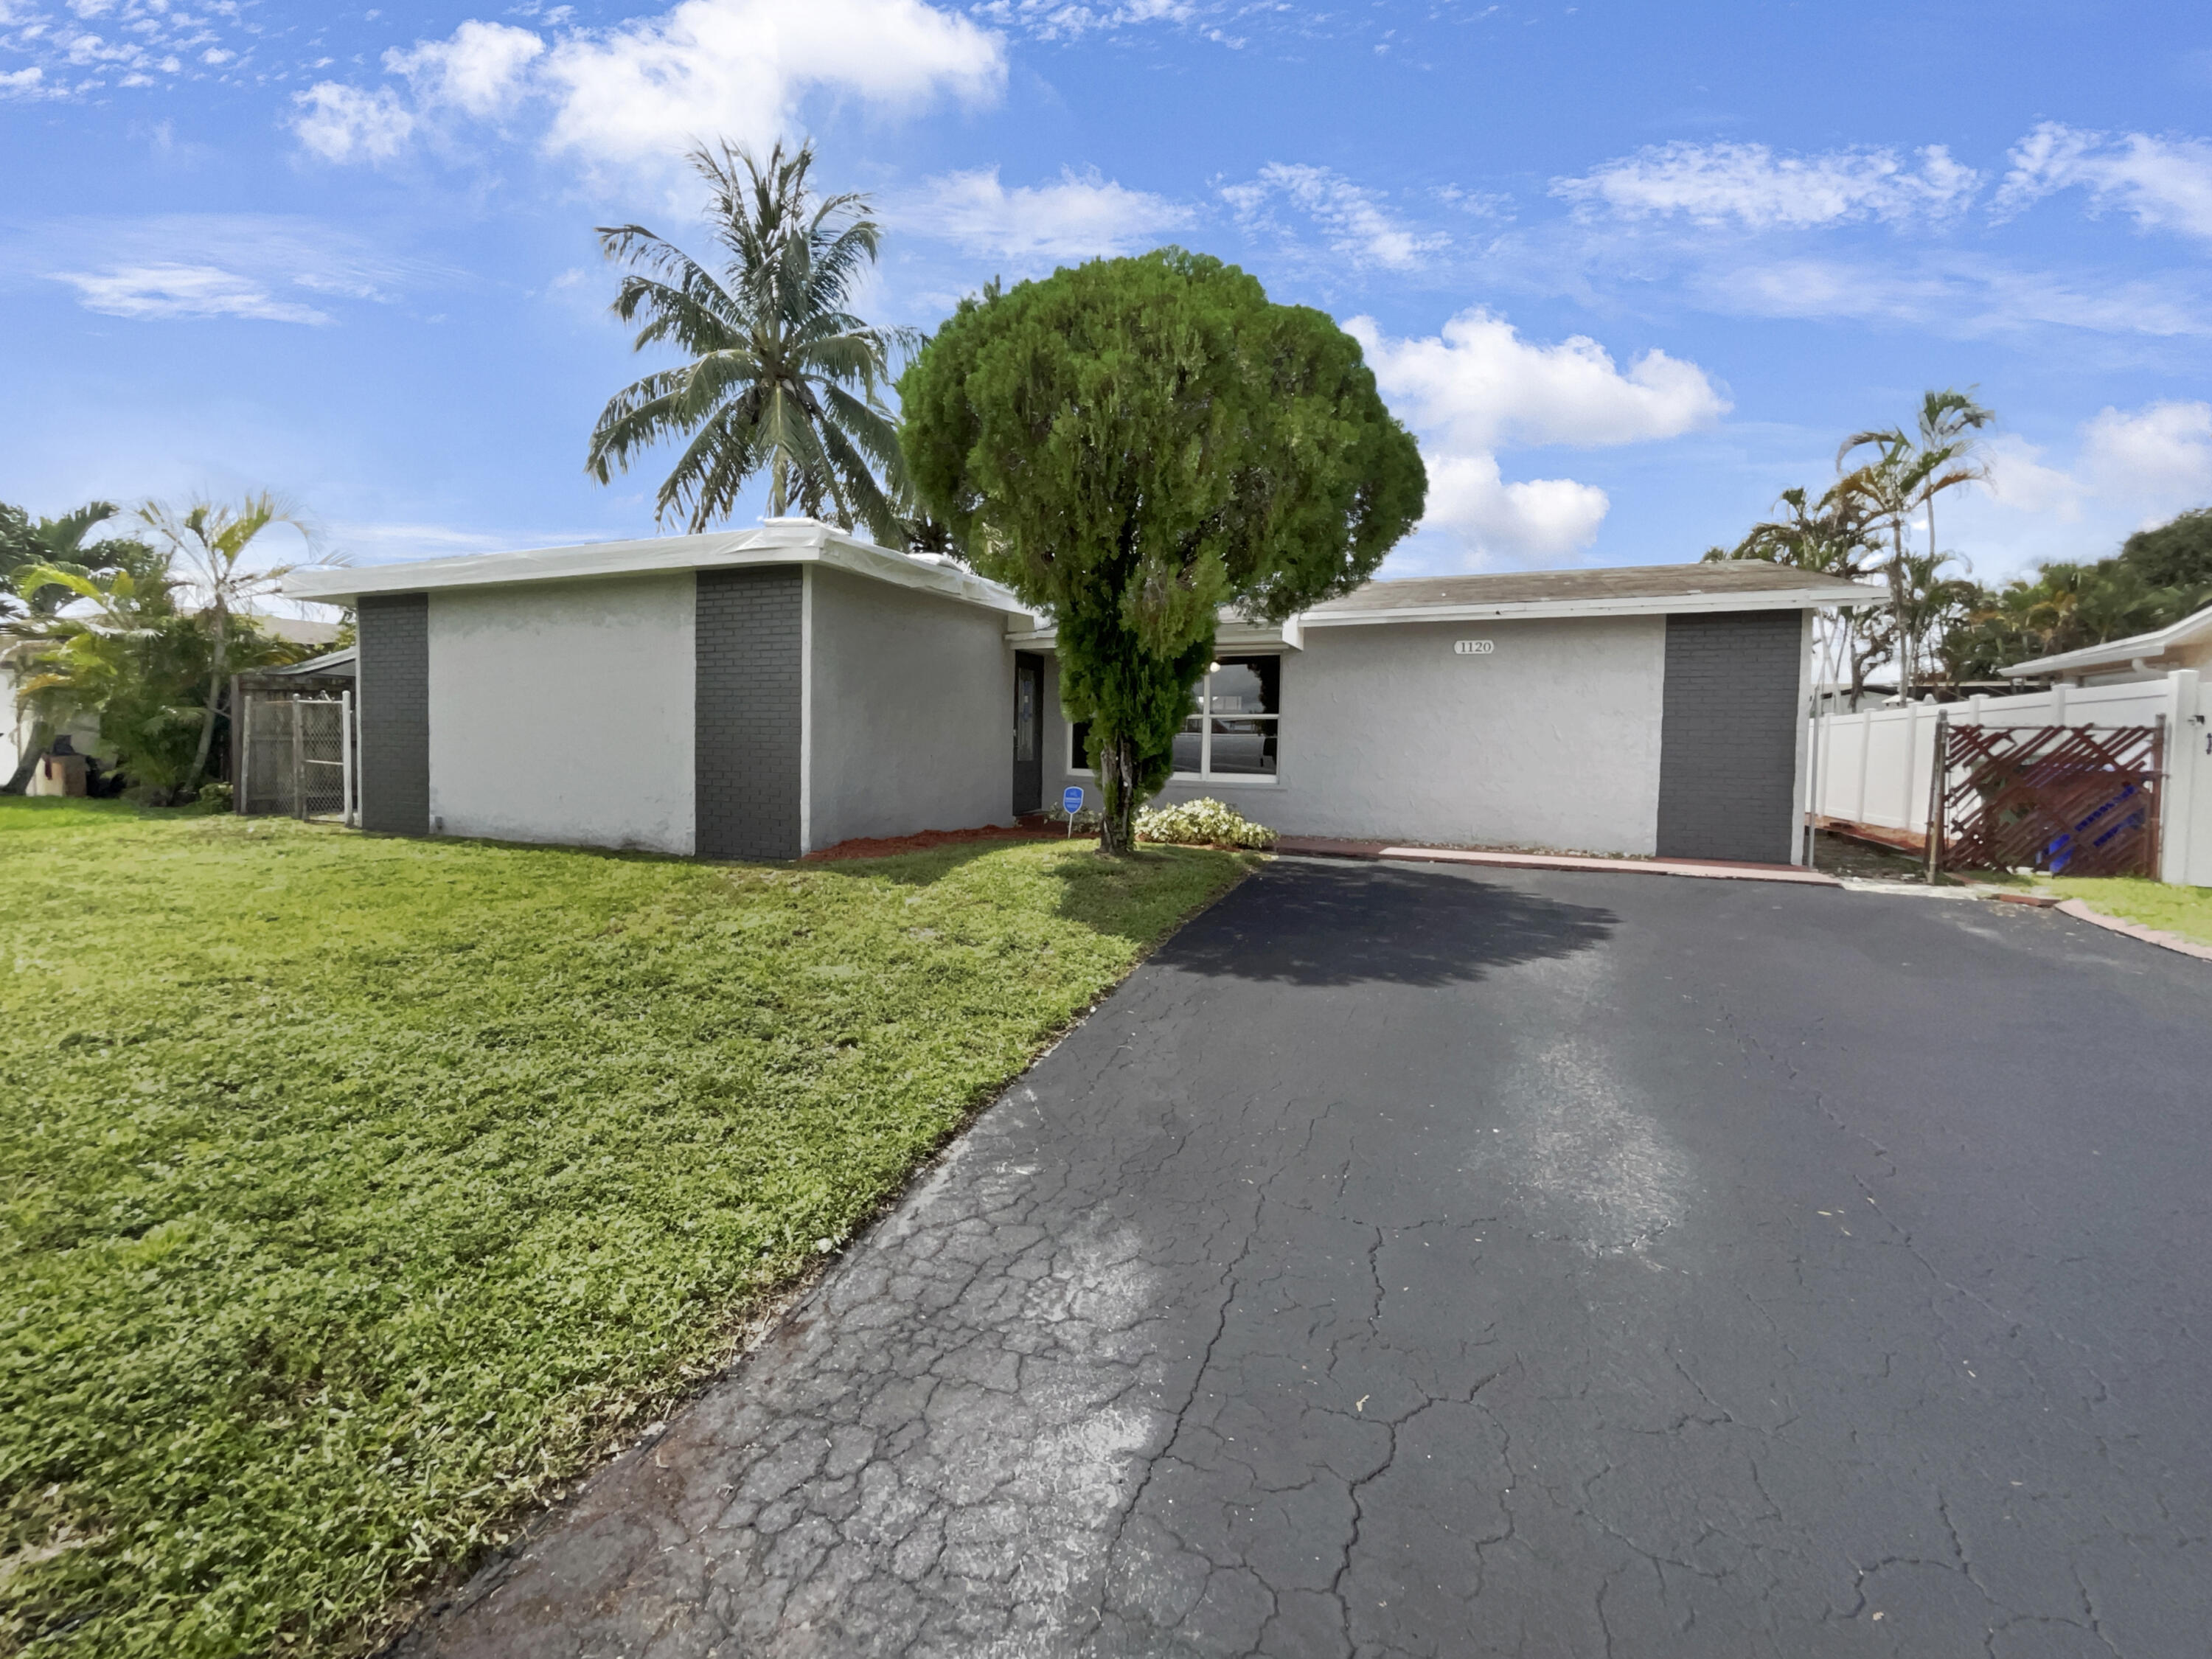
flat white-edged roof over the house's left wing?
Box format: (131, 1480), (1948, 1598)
(283, 518), (1031, 617)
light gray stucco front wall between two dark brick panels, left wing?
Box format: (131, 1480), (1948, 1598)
(429, 571), (695, 854)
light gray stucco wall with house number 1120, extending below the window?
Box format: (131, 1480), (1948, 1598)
(1044, 617), (1663, 854)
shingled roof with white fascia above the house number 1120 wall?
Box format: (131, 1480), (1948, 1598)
(1305, 560), (1887, 628)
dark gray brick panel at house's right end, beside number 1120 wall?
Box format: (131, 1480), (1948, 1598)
(1659, 611), (1805, 865)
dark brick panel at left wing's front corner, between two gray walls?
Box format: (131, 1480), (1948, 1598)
(692, 566), (803, 858)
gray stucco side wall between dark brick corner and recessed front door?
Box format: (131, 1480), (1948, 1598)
(805, 566), (1013, 852)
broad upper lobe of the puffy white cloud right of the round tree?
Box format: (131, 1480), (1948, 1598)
(1345, 307), (1728, 449)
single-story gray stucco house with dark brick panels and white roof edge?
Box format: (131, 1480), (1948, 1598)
(285, 520), (1882, 863)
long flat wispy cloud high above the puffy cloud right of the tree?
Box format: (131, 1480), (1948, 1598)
(1551, 142), (1980, 230)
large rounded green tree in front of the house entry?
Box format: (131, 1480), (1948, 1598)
(898, 248), (1427, 854)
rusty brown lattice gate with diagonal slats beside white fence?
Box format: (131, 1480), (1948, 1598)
(1929, 719), (2166, 876)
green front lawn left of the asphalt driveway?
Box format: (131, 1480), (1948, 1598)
(0, 799), (1248, 1659)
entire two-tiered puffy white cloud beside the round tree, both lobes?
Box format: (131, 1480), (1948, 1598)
(1345, 307), (1728, 560)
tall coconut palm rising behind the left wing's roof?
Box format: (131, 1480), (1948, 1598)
(584, 142), (911, 546)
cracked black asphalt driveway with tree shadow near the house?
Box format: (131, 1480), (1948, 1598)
(398, 858), (2212, 1659)
